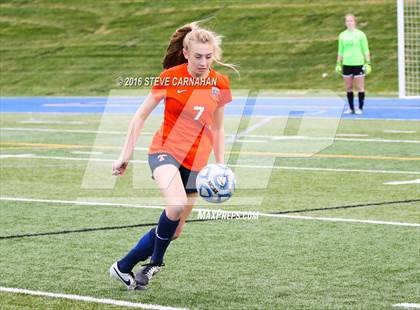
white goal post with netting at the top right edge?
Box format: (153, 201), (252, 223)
(397, 0), (420, 98)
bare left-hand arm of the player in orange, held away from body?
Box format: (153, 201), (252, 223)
(112, 94), (160, 175)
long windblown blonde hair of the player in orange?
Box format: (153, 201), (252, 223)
(162, 22), (239, 75)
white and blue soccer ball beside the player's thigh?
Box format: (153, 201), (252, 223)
(196, 164), (236, 203)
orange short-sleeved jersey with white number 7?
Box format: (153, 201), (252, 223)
(149, 63), (232, 171)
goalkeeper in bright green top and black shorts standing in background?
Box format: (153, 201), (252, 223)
(335, 14), (372, 114)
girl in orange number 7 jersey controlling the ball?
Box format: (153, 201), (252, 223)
(110, 22), (236, 289)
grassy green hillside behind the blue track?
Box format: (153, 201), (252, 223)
(0, 0), (397, 96)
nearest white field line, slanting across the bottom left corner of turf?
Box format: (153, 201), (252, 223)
(0, 286), (188, 310)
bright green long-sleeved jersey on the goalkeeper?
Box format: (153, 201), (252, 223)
(338, 29), (369, 66)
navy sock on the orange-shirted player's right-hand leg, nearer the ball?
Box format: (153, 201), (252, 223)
(151, 210), (179, 265)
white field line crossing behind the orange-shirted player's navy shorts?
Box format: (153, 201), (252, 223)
(0, 154), (420, 175)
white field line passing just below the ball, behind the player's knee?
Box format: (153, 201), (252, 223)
(0, 196), (420, 227)
